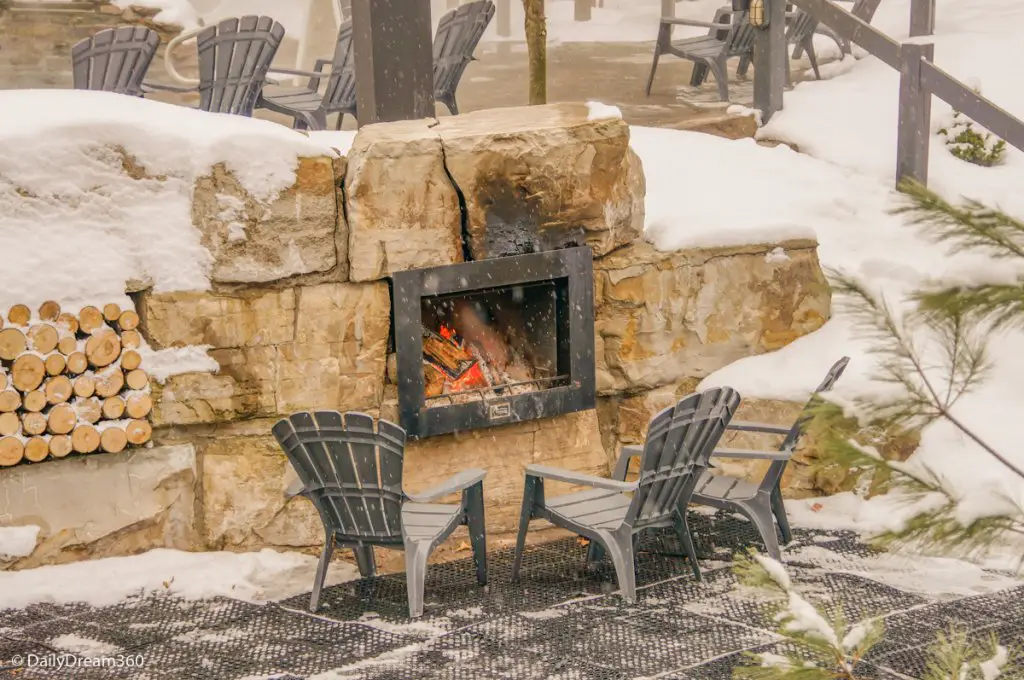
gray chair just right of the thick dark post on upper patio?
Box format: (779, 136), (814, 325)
(434, 0), (495, 115)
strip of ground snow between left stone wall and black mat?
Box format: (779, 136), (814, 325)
(0, 549), (358, 609)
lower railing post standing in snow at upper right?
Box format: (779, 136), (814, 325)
(896, 43), (935, 184)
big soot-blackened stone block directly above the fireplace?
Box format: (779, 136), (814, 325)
(436, 103), (645, 259)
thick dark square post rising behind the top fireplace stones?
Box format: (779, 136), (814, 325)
(352, 0), (434, 126)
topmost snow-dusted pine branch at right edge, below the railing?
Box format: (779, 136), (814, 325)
(893, 179), (1024, 258)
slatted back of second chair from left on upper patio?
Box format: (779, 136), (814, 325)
(198, 16), (285, 116)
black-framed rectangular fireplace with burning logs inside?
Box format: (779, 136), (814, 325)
(394, 247), (596, 438)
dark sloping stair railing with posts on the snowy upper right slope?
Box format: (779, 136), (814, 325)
(754, 0), (1024, 183)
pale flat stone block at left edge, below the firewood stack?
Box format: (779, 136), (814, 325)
(0, 445), (199, 568)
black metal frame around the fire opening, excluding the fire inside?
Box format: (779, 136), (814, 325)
(393, 247), (597, 439)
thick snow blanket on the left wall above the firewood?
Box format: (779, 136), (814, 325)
(0, 90), (334, 310)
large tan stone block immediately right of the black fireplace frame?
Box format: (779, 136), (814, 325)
(594, 241), (830, 394)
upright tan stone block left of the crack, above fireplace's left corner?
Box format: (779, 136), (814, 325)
(344, 119), (463, 281)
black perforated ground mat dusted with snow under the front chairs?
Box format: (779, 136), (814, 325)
(0, 515), (1024, 680)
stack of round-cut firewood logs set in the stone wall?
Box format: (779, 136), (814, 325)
(0, 302), (153, 467)
